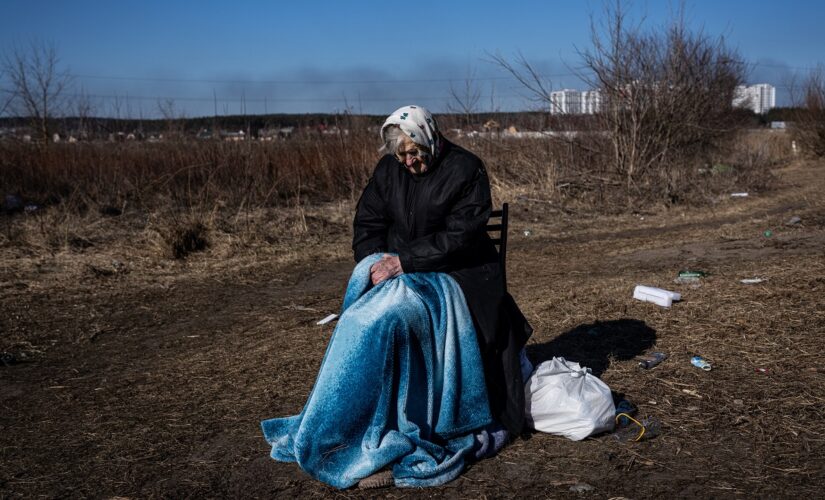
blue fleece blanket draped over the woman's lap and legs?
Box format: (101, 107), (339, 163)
(261, 255), (492, 488)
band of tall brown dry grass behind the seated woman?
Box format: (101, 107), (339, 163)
(0, 132), (790, 213)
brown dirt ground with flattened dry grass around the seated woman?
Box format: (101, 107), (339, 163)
(0, 158), (825, 498)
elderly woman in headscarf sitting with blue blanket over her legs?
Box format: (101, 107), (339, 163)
(262, 106), (532, 487)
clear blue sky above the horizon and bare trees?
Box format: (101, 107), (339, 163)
(0, 0), (825, 117)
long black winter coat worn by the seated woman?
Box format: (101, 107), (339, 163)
(352, 140), (532, 434)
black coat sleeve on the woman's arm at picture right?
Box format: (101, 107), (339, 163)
(398, 161), (492, 273)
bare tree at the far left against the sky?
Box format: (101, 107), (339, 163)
(2, 41), (72, 143)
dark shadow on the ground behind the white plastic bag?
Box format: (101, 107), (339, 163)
(527, 318), (656, 377)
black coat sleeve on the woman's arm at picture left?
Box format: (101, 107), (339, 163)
(352, 163), (390, 262)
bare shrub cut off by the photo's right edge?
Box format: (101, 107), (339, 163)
(791, 65), (825, 158)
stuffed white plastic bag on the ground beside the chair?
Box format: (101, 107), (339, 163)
(524, 358), (616, 441)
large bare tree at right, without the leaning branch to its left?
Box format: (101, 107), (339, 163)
(580, 0), (746, 190)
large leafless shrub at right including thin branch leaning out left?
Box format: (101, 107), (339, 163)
(493, 0), (745, 206)
